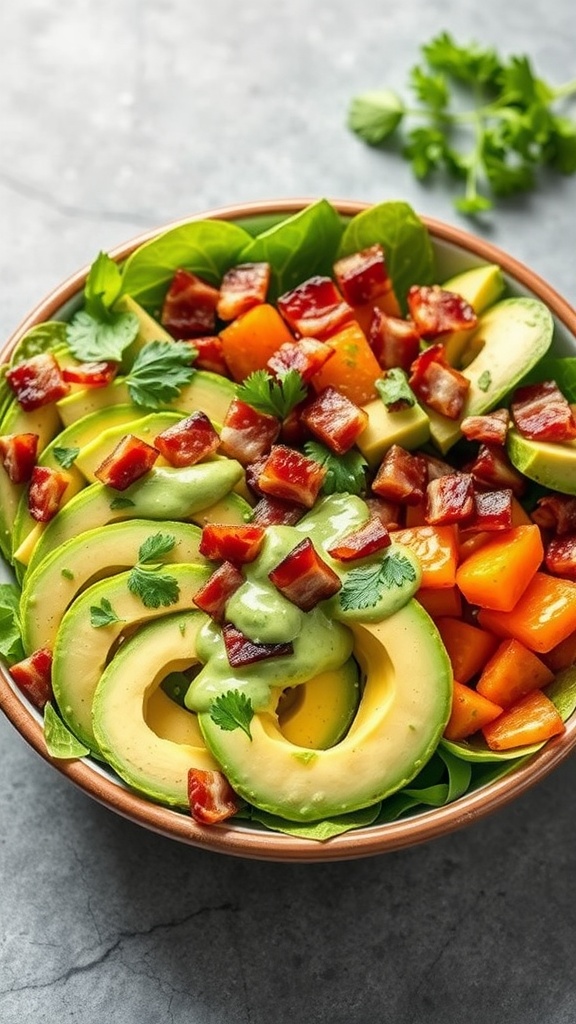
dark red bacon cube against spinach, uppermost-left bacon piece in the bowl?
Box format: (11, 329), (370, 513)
(160, 268), (219, 339)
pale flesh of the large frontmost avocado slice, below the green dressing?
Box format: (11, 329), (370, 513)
(194, 600), (452, 821)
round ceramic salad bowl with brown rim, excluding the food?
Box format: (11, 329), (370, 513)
(0, 193), (576, 862)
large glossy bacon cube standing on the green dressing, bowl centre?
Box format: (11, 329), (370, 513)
(269, 537), (342, 611)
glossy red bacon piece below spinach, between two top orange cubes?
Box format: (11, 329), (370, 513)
(277, 275), (354, 341)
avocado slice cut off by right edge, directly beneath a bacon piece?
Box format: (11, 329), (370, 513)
(506, 427), (576, 495)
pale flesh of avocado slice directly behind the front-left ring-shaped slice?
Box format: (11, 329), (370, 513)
(52, 564), (211, 754)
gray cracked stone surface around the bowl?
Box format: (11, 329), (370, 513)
(0, 0), (576, 1024)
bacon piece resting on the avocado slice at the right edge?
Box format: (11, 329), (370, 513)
(510, 381), (576, 441)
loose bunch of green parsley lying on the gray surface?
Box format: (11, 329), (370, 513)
(348, 32), (576, 215)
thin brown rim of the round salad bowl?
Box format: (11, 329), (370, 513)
(0, 198), (576, 862)
